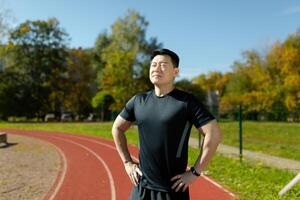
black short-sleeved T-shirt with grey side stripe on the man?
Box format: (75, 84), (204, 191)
(120, 88), (215, 192)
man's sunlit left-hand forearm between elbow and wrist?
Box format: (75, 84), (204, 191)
(112, 128), (132, 163)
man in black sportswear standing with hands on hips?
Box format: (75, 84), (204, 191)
(112, 49), (221, 200)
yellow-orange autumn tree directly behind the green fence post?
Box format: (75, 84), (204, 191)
(220, 50), (270, 119)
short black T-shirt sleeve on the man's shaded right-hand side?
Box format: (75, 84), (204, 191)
(187, 94), (215, 128)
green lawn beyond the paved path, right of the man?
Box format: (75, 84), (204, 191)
(192, 121), (300, 161)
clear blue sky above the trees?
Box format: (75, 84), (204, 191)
(0, 0), (300, 79)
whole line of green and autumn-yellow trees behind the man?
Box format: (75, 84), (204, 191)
(0, 10), (300, 121)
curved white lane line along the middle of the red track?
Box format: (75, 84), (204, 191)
(50, 136), (116, 200)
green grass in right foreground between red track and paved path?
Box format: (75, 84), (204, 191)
(189, 149), (300, 200)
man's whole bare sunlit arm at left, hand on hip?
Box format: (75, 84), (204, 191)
(112, 115), (142, 185)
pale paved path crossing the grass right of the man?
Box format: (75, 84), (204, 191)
(189, 138), (300, 173)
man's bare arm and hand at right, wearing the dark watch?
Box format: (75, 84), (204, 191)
(171, 120), (222, 191)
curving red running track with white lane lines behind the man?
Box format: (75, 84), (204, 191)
(1, 129), (234, 200)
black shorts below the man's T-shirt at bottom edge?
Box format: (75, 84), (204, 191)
(129, 185), (190, 200)
